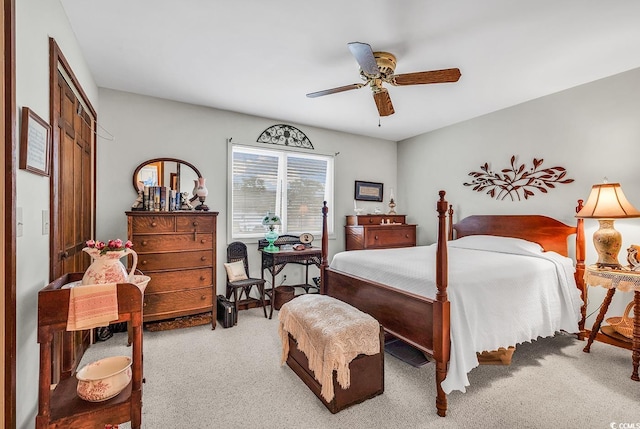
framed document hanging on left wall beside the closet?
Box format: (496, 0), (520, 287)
(19, 107), (51, 176)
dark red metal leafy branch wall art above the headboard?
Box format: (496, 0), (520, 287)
(464, 155), (573, 201)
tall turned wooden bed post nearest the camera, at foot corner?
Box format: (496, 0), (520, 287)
(433, 191), (451, 417)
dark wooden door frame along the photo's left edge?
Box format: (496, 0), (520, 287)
(0, 0), (17, 429)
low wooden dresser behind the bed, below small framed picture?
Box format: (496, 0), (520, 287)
(344, 214), (416, 250)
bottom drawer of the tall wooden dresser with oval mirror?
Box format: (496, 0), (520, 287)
(143, 287), (213, 321)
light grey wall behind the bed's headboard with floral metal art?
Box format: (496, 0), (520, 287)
(397, 69), (640, 328)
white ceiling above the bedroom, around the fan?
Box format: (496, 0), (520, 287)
(61, 0), (640, 141)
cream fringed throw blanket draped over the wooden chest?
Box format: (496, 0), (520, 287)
(278, 294), (380, 402)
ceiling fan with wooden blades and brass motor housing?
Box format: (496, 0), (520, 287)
(307, 42), (460, 116)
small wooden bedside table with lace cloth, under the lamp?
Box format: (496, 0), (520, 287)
(583, 265), (640, 381)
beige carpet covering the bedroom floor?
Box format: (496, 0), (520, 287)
(82, 309), (640, 429)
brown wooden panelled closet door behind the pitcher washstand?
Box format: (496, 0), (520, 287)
(50, 62), (94, 382)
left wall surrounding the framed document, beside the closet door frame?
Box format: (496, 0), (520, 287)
(16, 0), (98, 428)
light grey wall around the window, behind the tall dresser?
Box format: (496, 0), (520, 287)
(96, 89), (396, 300)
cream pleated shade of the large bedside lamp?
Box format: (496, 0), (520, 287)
(576, 183), (640, 219)
